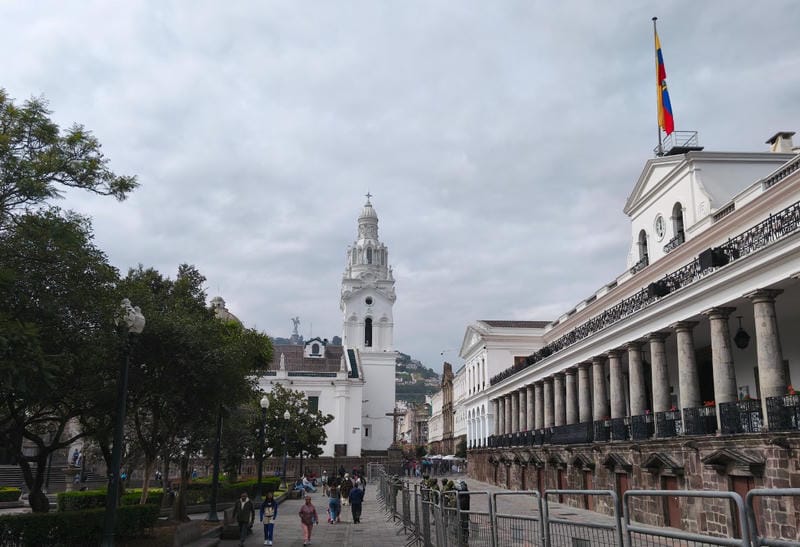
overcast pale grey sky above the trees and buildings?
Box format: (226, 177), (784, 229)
(0, 0), (800, 370)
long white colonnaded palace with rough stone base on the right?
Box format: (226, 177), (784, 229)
(462, 132), (800, 539)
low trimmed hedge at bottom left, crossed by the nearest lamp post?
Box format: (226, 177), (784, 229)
(0, 504), (159, 547)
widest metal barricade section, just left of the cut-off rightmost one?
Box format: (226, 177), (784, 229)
(622, 490), (750, 547)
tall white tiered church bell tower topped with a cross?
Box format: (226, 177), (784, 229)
(339, 193), (397, 451)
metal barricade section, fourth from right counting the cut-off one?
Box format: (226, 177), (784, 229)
(492, 490), (548, 546)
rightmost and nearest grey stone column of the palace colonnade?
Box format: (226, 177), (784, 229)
(746, 289), (787, 430)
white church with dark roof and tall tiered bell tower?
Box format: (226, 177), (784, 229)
(259, 196), (397, 457)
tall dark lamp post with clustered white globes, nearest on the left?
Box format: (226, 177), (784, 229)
(102, 298), (145, 547)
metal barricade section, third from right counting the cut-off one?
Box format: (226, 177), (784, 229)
(543, 490), (623, 547)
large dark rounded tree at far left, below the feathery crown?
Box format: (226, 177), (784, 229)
(0, 209), (120, 512)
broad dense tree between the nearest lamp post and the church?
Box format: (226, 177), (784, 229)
(102, 265), (272, 519)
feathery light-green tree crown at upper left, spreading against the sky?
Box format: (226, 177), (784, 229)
(0, 88), (137, 231)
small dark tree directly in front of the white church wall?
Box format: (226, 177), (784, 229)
(264, 384), (333, 472)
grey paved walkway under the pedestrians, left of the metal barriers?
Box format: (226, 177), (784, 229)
(220, 482), (407, 547)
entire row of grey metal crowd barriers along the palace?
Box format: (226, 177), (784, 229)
(375, 471), (800, 547)
